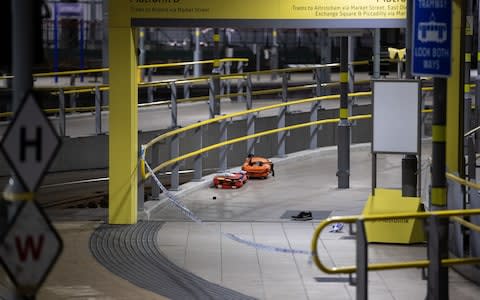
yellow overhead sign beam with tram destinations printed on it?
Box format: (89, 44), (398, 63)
(110, 0), (407, 26)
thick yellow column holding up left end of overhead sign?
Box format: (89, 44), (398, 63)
(108, 27), (138, 224)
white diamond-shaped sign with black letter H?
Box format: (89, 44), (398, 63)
(0, 93), (60, 192)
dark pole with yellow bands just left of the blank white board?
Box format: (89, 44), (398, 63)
(337, 37), (350, 188)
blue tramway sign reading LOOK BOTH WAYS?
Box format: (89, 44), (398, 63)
(412, 0), (452, 77)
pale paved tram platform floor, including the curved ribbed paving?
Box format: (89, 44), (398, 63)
(0, 140), (480, 300)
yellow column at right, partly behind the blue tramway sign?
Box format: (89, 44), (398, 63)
(446, 0), (465, 174)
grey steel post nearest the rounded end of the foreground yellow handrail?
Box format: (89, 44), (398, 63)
(355, 219), (368, 300)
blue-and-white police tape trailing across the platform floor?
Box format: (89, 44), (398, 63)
(145, 161), (311, 255)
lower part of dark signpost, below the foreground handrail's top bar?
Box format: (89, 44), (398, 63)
(427, 216), (449, 300)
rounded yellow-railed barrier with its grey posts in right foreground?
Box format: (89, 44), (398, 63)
(311, 209), (480, 300)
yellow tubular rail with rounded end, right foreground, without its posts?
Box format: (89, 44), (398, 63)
(311, 209), (480, 274)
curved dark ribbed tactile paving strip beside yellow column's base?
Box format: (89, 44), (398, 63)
(90, 221), (255, 300)
